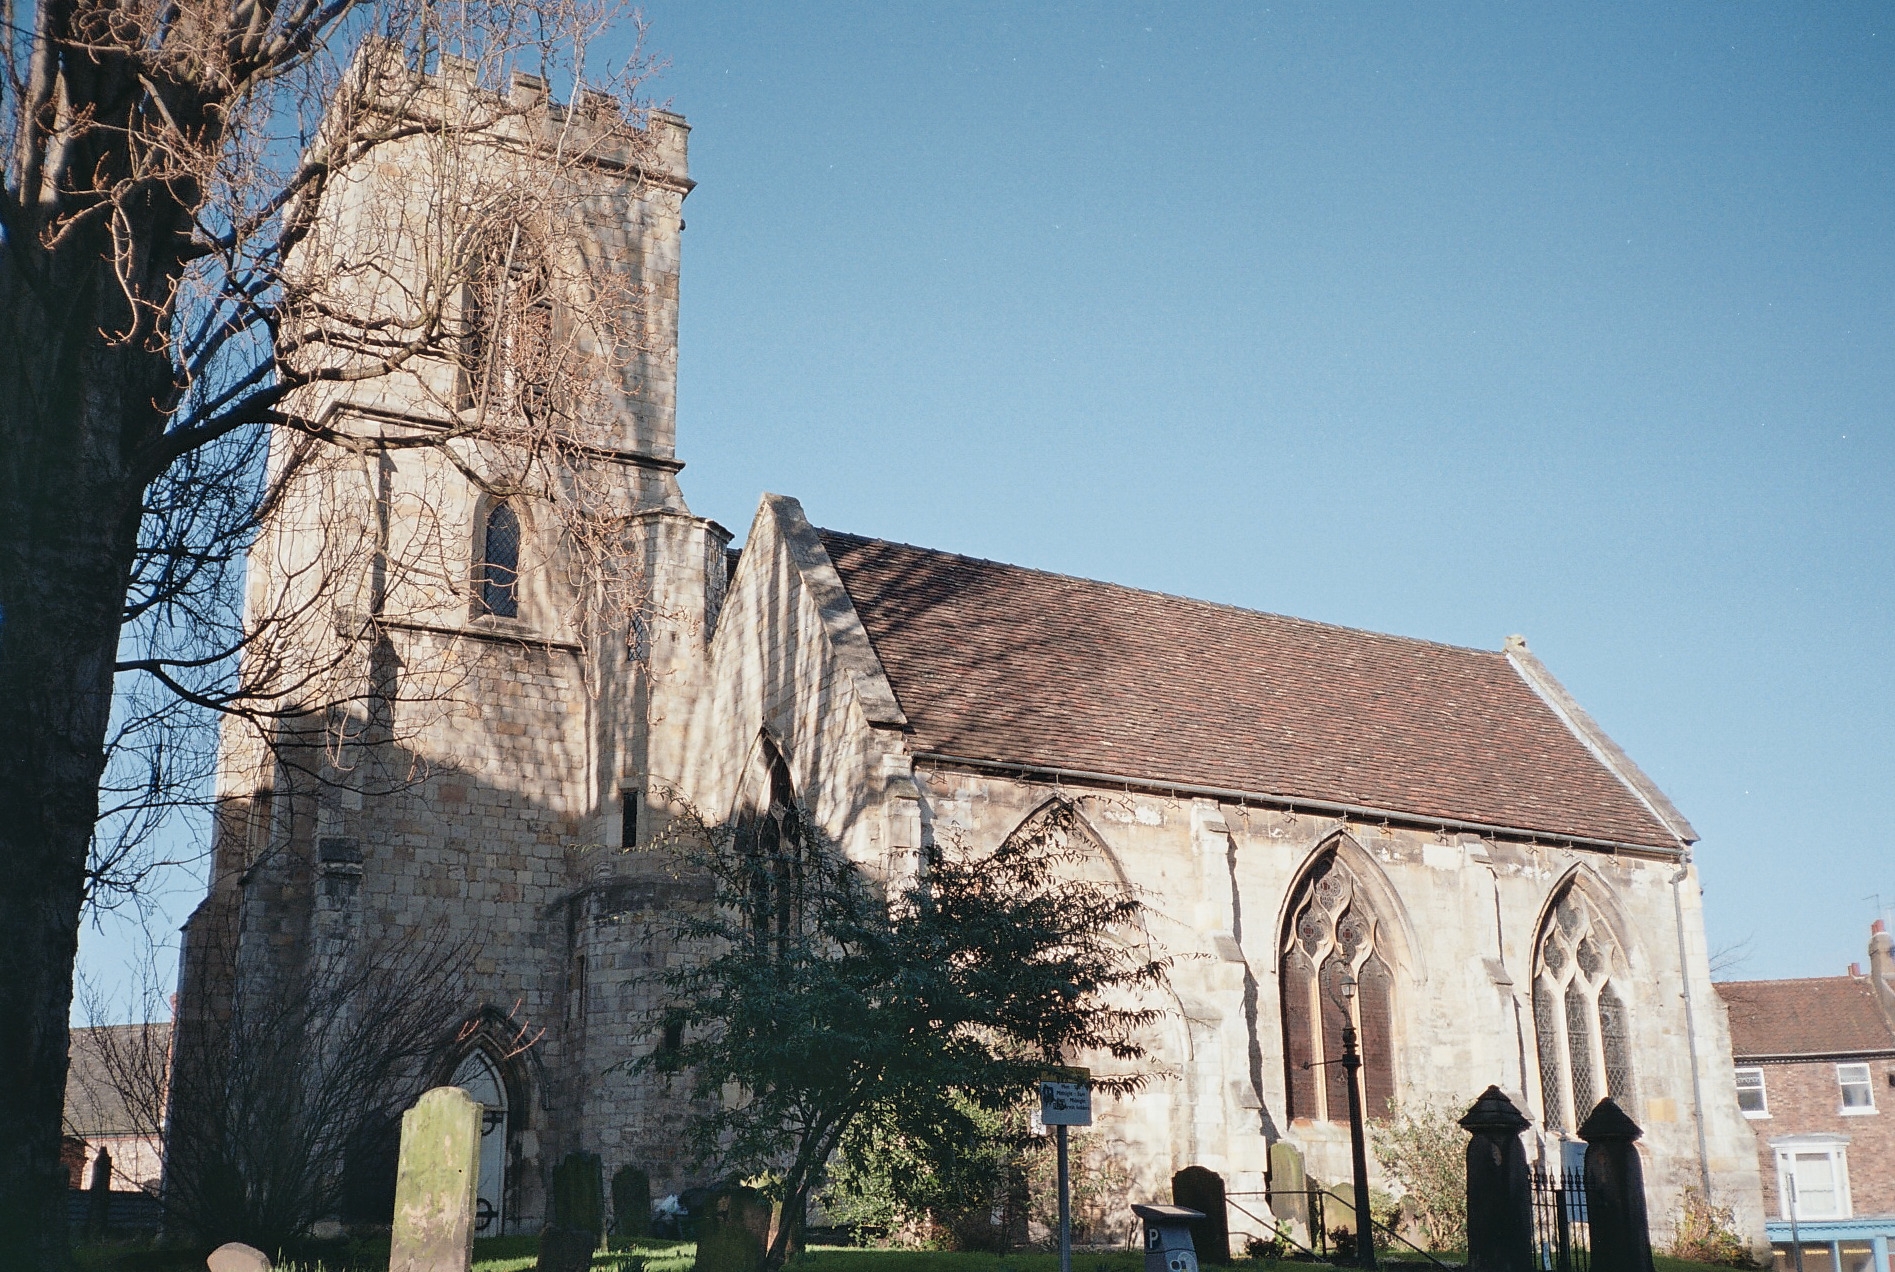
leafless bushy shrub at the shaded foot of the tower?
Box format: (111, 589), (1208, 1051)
(93, 917), (472, 1251)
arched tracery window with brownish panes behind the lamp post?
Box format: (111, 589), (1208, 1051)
(1279, 849), (1395, 1122)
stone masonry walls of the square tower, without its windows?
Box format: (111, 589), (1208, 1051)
(180, 84), (704, 1232)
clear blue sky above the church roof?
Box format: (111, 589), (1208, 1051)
(70, 0), (1895, 1016)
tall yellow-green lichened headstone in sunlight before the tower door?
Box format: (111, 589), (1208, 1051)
(388, 1086), (481, 1272)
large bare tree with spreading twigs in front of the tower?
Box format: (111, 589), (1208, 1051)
(0, 0), (669, 1266)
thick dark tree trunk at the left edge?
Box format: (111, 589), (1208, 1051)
(0, 244), (171, 1268)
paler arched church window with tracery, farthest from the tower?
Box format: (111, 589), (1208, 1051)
(1533, 885), (1632, 1132)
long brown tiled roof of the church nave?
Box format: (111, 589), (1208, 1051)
(819, 531), (1677, 845)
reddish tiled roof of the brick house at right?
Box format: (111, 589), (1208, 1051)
(1717, 976), (1895, 1060)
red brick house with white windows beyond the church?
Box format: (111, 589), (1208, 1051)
(1717, 919), (1895, 1272)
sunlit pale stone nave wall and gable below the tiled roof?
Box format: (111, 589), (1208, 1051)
(692, 499), (1762, 1240)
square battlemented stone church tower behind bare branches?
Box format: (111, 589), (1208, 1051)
(180, 59), (730, 1236)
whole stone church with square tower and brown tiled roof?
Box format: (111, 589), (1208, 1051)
(180, 54), (1762, 1236)
